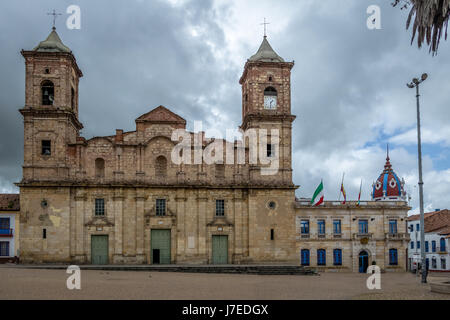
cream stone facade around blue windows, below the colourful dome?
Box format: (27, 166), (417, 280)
(295, 201), (409, 272)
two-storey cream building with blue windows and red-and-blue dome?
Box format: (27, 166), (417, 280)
(295, 155), (410, 272)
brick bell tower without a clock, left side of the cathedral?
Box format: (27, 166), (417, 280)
(19, 27), (83, 181)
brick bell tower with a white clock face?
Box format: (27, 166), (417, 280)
(239, 36), (295, 185)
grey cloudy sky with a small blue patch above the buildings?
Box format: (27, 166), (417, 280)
(0, 0), (450, 212)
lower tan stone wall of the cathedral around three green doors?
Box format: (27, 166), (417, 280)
(21, 187), (295, 264)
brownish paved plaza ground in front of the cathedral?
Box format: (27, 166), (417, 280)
(0, 267), (450, 300)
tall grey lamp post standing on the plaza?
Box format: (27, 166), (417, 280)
(407, 73), (428, 283)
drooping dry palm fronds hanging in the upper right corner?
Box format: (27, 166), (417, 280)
(392, 0), (450, 55)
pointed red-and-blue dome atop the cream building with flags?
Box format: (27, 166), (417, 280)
(372, 153), (405, 200)
